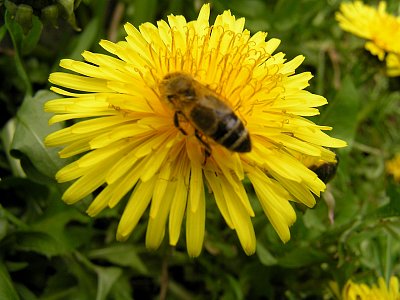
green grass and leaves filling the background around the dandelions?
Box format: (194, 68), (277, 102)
(0, 0), (400, 300)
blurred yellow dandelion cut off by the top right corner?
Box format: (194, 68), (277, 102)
(336, 1), (400, 76)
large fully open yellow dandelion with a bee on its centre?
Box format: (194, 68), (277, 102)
(45, 4), (346, 256)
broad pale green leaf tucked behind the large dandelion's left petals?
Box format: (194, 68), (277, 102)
(11, 91), (67, 180)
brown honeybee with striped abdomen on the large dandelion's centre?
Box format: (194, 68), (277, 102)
(159, 72), (251, 156)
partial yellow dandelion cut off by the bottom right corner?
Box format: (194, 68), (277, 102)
(342, 276), (400, 300)
